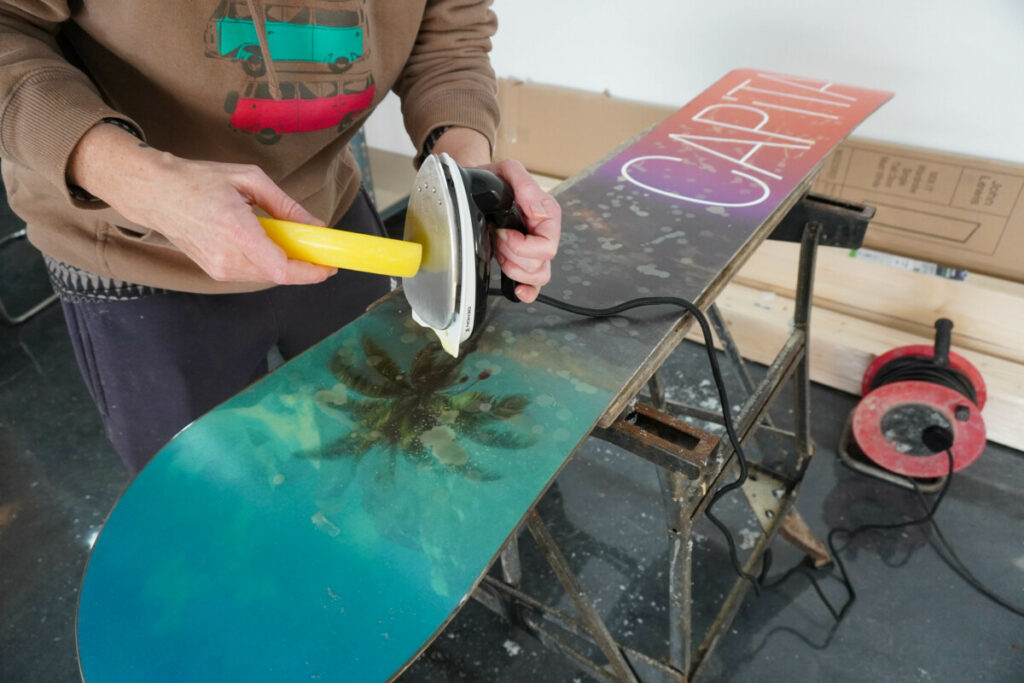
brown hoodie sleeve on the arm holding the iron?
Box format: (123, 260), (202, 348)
(394, 0), (499, 160)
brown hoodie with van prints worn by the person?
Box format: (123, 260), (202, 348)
(0, 0), (498, 293)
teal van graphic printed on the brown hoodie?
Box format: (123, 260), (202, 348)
(205, 0), (366, 77)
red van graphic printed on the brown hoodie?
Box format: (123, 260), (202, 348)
(224, 76), (377, 144)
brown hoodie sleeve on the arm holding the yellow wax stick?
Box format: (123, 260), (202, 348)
(0, 0), (138, 206)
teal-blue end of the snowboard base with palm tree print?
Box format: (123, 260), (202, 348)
(78, 295), (610, 681)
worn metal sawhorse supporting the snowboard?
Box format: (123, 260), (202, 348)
(473, 195), (874, 681)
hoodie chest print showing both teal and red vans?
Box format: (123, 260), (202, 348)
(204, 0), (376, 144)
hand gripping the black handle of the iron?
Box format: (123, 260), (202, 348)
(481, 160), (562, 303)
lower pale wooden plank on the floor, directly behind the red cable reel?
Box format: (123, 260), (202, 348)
(688, 284), (1024, 450)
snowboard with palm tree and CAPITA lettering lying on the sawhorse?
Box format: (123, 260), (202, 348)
(77, 70), (890, 683)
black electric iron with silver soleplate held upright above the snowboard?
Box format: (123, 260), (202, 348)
(402, 154), (526, 356)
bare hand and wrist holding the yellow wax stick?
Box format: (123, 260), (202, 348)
(68, 124), (337, 285)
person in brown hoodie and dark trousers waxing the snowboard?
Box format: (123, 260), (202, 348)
(0, 0), (560, 474)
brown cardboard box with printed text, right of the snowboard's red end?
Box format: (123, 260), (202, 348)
(814, 138), (1024, 282)
